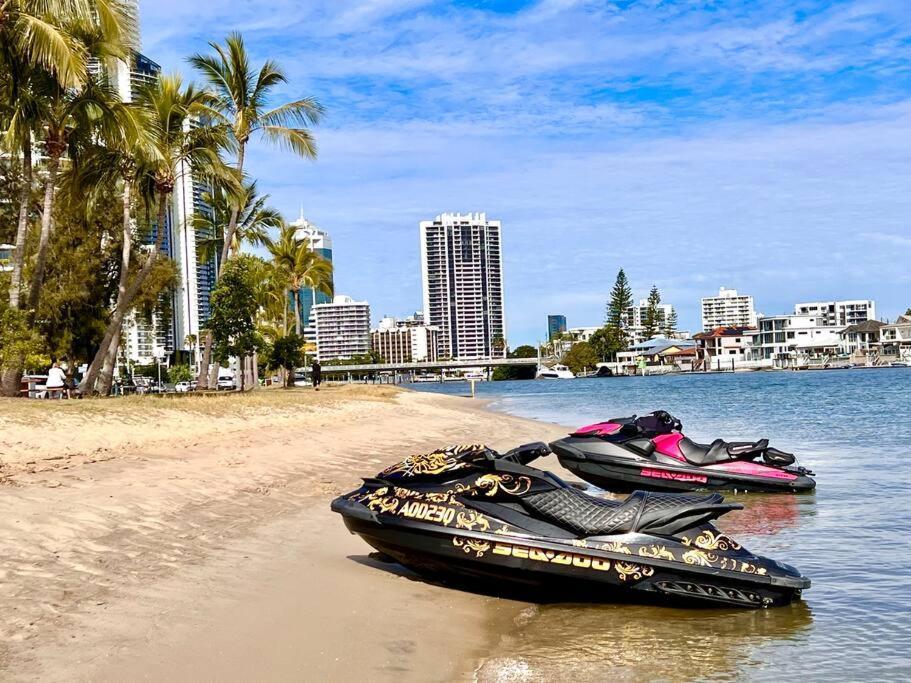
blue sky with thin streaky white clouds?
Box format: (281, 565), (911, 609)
(141, 0), (911, 346)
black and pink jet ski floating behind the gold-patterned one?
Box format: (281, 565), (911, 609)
(550, 410), (816, 493)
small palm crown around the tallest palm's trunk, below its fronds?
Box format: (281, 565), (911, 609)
(193, 181), (282, 262)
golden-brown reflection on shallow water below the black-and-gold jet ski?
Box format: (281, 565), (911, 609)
(478, 602), (813, 682)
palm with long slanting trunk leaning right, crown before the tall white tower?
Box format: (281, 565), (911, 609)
(80, 76), (233, 394)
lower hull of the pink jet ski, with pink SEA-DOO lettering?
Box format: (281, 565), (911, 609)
(550, 437), (816, 493)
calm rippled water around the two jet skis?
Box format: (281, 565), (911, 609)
(414, 368), (911, 681)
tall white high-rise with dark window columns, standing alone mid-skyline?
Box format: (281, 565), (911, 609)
(420, 213), (506, 360)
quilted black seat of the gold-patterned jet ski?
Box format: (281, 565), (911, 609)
(522, 487), (742, 538)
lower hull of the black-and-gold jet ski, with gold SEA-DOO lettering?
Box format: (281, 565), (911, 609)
(332, 497), (810, 608)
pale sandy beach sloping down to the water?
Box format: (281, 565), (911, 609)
(0, 386), (563, 681)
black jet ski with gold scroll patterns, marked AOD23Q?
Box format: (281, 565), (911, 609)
(332, 443), (810, 607)
